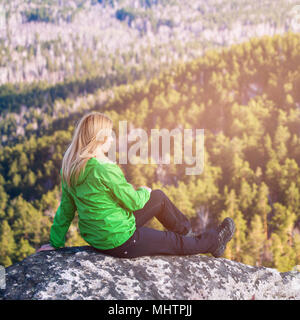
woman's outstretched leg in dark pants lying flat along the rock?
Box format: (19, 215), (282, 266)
(94, 227), (218, 258)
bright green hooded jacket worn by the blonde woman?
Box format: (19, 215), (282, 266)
(50, 158), (150, 249)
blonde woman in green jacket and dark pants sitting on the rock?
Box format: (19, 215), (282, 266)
(37, 112), (235, 258)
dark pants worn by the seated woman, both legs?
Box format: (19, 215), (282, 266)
(94, 189), (217, 258)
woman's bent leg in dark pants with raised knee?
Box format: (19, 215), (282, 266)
(133, 189), (191, 235)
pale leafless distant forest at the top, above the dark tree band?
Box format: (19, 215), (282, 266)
(0, 0), (297, 90)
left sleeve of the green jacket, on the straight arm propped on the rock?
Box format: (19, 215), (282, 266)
(50, 171), (77, 249)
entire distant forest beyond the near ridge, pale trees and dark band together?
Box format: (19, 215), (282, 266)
(0, 0), (297, 146)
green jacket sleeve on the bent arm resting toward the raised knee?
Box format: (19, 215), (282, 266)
(98, 164), (150, 212)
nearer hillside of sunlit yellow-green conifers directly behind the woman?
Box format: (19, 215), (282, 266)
(0, 32), (300, 271)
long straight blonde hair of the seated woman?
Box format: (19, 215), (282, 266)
(62, 111), (113, 187)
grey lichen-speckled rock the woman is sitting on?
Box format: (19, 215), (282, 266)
(0, 246), (300, 300)
